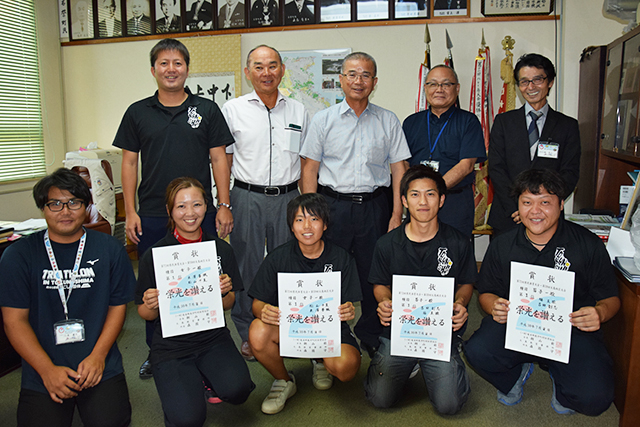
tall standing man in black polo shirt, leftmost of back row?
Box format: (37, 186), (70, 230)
(113, 39), (233, 378)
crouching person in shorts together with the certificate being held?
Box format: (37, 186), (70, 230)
(249, 193), (362, 414)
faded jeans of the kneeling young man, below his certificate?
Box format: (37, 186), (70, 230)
(364, 337), (469, 415)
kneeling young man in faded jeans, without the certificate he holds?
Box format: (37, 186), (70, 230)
(364, 165), (478, 414)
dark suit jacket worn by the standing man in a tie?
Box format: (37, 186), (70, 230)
(488, 107), (580, 232)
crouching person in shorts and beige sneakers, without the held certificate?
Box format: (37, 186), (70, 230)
(249, 193), (362, 414)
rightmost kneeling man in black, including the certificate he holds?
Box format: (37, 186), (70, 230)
(465, 169), (620, 415)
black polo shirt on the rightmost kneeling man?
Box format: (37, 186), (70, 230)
(477, 218), (618, 311)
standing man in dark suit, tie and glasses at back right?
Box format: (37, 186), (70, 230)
(488, 53), (580, 233)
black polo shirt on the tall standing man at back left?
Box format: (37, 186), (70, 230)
(113, 88), (234, 217)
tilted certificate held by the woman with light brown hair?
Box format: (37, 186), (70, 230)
(151, 241), (224, 338)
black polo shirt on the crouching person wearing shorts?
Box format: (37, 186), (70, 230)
(249, 239), (362, 307)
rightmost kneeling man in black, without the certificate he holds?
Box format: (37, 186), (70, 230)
(465, 169), (620, 416)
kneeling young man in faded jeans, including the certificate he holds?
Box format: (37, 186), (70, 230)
(365, 165), (477, 414)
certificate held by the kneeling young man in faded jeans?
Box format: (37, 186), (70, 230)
(391, 275), (455, 362)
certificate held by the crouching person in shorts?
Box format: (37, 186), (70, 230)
(278, 271), (342, 358)
